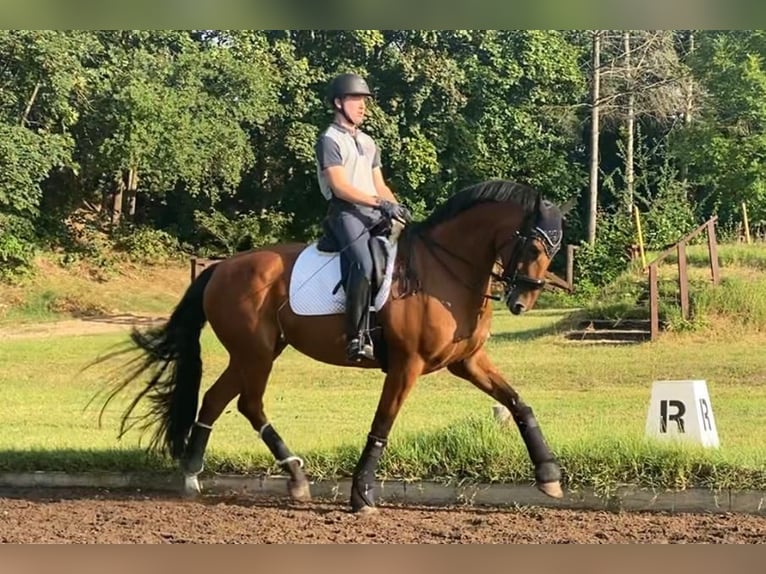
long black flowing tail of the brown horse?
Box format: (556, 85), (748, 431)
(95, 265), (216, 458)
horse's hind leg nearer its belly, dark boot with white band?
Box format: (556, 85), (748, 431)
(237, 355), (311, 501)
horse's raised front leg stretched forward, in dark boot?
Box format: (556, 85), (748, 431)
(447, 349), (564, 498)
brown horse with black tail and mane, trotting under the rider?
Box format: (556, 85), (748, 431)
(97, 180), (564, 511)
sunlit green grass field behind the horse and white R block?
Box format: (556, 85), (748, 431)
(0, 310), (766, 496)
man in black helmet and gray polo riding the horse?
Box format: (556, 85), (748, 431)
(315, 74), (410, 362)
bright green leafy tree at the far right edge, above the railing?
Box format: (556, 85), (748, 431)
(673, 30), (766, 225)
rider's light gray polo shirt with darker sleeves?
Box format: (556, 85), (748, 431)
(315, 123), (380, 200)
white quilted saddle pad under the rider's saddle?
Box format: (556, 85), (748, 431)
(290, 243), (397, 315)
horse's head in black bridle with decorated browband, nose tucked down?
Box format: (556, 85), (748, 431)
(500, 197), (571, 315)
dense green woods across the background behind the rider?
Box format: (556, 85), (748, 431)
(0, 30), (766, 284)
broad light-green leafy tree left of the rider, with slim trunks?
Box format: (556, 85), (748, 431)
(77, 31), (276, 224)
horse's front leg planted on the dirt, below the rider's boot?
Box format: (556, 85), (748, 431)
(351, 358), (423, 513)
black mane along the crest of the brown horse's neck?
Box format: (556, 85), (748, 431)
(398, 179), (540, 293)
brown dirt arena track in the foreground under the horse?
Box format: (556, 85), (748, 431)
(0, 488), (766, 544)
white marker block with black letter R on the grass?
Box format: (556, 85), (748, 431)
(646, 380), (719, 448)
